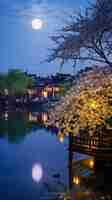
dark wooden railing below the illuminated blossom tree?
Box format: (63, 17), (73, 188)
(68, 135), (112, 159)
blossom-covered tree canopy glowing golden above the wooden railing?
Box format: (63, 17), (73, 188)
(48, 66), (112, 134)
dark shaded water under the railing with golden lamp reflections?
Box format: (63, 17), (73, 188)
(62, 136), (112, 200)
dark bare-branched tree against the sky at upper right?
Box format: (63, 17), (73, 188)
(48, 0), (112, 70)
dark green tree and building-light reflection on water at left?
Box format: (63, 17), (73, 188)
(0, 112), (48, 143)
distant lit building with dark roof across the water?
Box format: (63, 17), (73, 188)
(27, 73), (74, 98)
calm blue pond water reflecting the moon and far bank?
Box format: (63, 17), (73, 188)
(0, 112), (111, 200)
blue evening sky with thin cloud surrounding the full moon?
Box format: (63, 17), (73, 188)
(0, 0), (91, 75)
